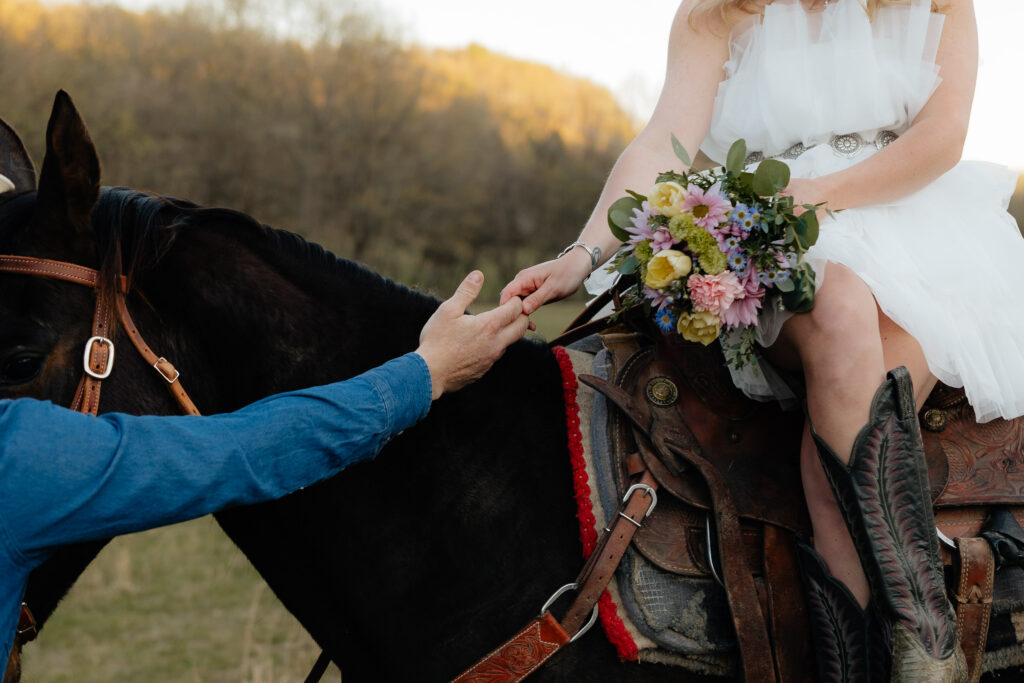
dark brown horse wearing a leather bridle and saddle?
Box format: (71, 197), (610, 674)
(0, 93), (720, 681)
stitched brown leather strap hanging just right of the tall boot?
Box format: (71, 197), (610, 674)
(954, 538), (995, 683)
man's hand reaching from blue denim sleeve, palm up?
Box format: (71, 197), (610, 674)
(416, 270), (529, 398)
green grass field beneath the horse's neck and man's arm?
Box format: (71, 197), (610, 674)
(24, 302), (582, 683)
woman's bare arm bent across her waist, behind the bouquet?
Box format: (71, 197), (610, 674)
(786, 0), (978, 210)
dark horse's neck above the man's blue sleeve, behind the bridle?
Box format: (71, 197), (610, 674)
(141, 222), (436, 412)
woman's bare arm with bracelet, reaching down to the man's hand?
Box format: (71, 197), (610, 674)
(501, 0), (729, 315)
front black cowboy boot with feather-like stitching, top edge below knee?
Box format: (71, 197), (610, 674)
(811, 368), (968, 683)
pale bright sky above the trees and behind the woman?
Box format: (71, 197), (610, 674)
(97, 0), (1024, 169)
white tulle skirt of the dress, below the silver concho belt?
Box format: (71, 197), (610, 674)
(733, 144), (1024, 422)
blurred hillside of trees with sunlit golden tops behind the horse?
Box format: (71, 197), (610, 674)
(0, 0), (634, 297)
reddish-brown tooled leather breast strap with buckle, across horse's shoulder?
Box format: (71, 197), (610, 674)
(455, 471), (657, 683)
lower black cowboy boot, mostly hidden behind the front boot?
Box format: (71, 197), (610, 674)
(797, 538), (890, 683)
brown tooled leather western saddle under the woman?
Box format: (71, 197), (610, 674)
(581, 325), (1024, 681)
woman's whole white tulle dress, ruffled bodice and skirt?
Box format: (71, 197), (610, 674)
(701, 0), (1024, 421)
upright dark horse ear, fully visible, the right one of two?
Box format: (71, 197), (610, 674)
(36, 90), (99, 232)
